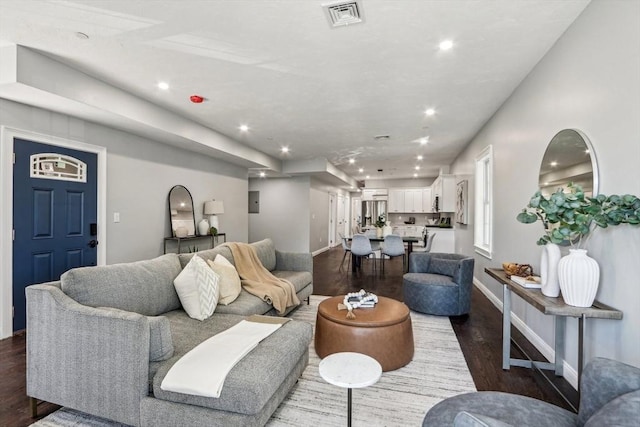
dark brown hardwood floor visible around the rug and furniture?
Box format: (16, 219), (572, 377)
(0, 247), (578, 427)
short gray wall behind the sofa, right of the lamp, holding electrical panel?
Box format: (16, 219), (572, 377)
(245, 177), (310, 252)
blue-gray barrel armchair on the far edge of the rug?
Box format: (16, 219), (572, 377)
(402, 252), (474, 316)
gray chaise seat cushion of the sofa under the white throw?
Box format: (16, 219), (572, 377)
(153, 310), (312, 414)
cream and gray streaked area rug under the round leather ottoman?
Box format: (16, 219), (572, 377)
(33, 295), (476, 427)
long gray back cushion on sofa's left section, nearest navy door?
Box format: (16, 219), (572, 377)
(60, 254), (181, 316)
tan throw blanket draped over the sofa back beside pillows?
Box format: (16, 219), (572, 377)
(226, 242), (300, 316)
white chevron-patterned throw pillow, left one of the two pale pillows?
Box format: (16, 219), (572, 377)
(173, 255), (220, 320)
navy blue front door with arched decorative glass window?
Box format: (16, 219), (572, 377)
(13, 138), (98, 332)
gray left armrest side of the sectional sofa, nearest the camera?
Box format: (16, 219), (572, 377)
(26, 285), (149, 425)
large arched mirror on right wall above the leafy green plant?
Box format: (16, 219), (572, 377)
(538, 129), (598, 197)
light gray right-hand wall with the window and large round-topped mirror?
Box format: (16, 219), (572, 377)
(452, 0), (640, 382)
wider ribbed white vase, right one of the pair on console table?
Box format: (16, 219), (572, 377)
(558, 249), (600, 307)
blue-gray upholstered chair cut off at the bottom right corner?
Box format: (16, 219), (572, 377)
(422, 358), (640, 427)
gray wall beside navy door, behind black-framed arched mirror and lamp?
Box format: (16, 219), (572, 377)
(0, 100), (248, 264)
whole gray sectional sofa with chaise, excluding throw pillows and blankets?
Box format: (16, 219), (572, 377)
(26, 239), (313, 426)
